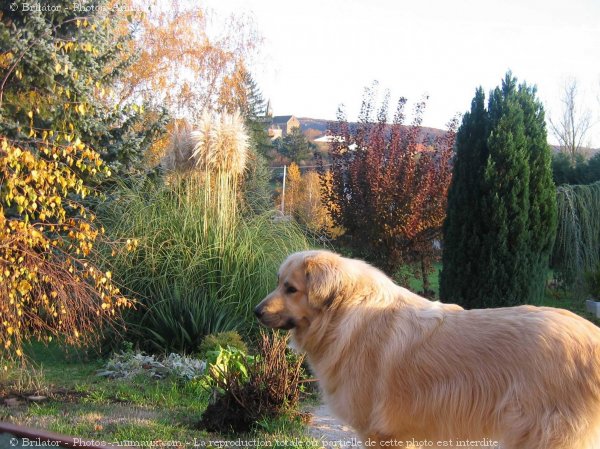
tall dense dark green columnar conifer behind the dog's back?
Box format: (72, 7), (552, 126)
(440, 72), (556, 308)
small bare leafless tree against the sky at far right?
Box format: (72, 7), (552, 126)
(549, 79), (592, 164)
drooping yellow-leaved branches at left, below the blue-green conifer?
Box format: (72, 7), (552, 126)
(0, 138), (134, 358)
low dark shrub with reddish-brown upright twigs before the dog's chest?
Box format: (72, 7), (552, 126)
(199, 332), (303, 432)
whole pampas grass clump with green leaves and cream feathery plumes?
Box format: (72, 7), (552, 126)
(99, 115), (309, 353)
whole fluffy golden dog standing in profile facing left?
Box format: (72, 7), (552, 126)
(254, 251), (600, 449)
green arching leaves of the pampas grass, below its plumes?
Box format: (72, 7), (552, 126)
(98, 182), (309, 352)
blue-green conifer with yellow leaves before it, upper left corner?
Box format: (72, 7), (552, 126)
(0, 0), (167, 175)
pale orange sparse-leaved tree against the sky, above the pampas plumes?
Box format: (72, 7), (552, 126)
(118, 0), (260, 121)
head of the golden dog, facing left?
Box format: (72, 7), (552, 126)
(254, 251), (348, 329)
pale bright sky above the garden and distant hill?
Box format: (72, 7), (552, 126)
(204, 0), (600, 147)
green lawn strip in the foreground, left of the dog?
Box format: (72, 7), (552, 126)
(0, 345), (318, 448)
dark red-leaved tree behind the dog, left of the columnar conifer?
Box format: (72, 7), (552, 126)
(324, 86), (455, 289)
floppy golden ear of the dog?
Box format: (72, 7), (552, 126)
(304, 252), (348, 309)
